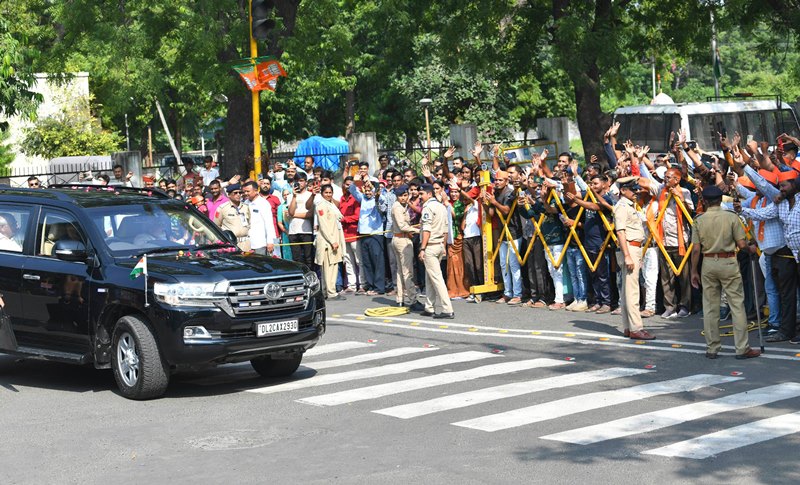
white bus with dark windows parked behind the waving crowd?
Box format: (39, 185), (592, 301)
(614, 98), (800, 153)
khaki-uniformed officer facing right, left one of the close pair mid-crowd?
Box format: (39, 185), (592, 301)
(391, 185), (419, 306)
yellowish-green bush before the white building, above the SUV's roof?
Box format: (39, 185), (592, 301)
(20, 98), (124, 159)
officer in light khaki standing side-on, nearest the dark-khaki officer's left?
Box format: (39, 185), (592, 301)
(614, 177), (656, 340)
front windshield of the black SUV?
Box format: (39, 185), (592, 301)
(86, 203), (228, 257)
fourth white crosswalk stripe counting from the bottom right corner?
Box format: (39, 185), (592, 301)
(373, 367), (652, 419)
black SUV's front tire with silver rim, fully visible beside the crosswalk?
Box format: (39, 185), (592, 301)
(111, 315), (169, 399)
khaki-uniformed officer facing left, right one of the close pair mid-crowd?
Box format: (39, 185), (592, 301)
(419, 184), (455, 318)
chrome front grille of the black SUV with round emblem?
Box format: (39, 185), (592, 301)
(228, 274), (308, 316)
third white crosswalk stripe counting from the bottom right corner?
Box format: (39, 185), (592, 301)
(453, 374), (741, 432)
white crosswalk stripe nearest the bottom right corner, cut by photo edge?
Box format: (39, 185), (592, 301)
(642, 412), (800, 460)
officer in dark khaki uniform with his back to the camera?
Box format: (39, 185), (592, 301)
(692, 185), (761, 359)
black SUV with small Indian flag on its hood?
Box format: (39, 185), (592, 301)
(0, 186), (325, 399)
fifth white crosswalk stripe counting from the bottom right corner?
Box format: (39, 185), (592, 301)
(299, 359), (572, 406)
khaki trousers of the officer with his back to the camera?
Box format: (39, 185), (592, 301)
(700, 257), (749, 354)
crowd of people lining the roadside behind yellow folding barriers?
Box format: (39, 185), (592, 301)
(21, 124), (800, 358)
